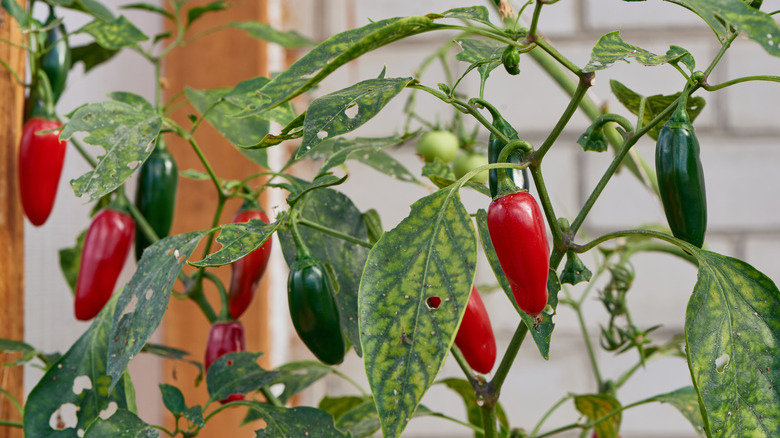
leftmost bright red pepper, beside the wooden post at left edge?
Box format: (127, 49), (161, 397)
(19, 117), (66, 226)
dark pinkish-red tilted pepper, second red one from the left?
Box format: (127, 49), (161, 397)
(75, 209), (135, 321)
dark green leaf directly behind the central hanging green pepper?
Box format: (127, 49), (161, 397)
(279, 189), (368, 356)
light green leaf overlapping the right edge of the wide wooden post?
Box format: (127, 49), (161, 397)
(185, 87), (270, 168)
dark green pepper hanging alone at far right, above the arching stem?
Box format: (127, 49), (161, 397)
(655, 104), (707, 248)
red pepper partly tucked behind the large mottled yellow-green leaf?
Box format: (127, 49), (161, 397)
(455, 286), (496, 374)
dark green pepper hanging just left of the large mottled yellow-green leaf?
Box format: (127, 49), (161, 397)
(287, 257), (347, 365)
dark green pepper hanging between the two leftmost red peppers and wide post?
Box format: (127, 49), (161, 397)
(135, 137), (179, 260)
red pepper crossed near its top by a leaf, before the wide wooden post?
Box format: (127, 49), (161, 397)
(228, 208), (272, 318)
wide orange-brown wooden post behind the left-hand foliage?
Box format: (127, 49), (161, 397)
(163, 0), (278, 437)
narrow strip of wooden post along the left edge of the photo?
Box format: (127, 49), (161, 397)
(0, 1), (24, 438)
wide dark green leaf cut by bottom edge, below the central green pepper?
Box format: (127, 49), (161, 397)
(249, 402), (349, 438)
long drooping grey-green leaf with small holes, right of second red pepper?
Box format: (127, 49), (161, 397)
(107, 231), (207, 388)
